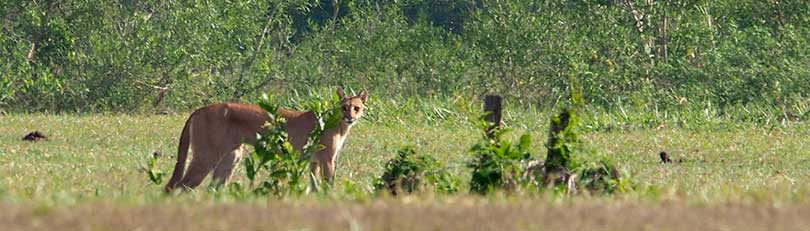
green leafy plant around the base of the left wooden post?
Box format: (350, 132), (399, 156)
(467, 120), (533, 194)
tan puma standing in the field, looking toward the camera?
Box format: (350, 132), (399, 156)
(165, 89), (368, 192)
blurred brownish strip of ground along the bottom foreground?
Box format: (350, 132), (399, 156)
(0, 200), (810, 230)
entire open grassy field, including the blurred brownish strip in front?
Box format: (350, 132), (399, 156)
(0, 107), (810, 230)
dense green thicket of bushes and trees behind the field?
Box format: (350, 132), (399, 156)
(0, 0), (810, 119)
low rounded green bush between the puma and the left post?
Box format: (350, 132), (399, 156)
(374, 147), (459, 195)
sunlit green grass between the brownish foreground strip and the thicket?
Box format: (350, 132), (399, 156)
(0, 104), (810, 204)
